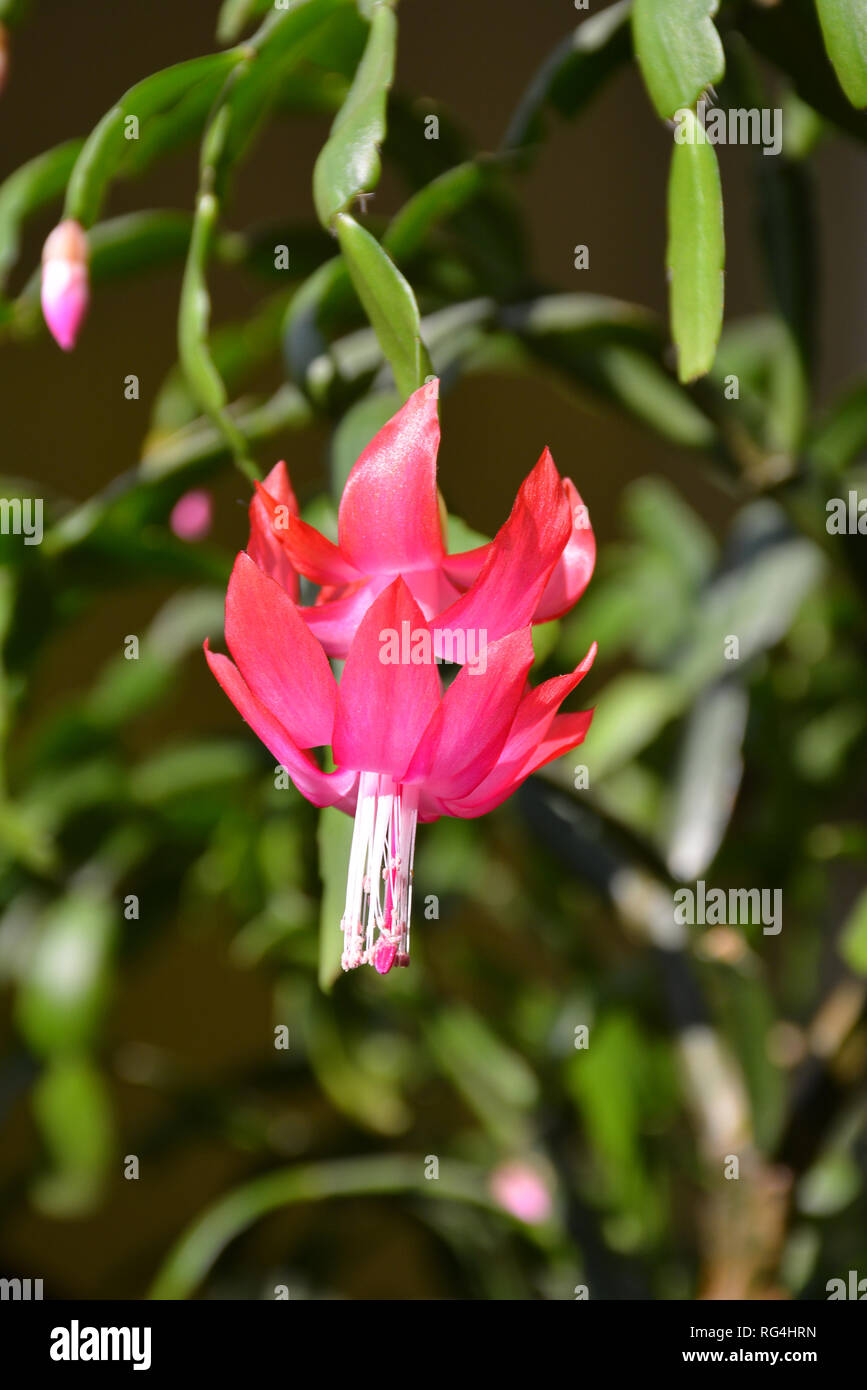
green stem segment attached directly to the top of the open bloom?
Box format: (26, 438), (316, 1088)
(335, 213), (434, 398)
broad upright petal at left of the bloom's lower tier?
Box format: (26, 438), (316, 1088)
(225, 550), (338, 748)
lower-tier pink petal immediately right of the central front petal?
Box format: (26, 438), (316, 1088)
(404, 627), (534, 798)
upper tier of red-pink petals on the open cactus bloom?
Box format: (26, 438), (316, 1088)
(247, 381), (596, 656)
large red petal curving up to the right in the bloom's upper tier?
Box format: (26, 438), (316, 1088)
(431, 449), (571, 642)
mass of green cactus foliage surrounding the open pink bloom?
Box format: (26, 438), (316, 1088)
(0, 0), (867, 1298)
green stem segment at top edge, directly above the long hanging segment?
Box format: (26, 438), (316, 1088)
(632, 0), (725, 121)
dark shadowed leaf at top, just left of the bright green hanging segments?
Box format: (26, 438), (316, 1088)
(502, 0), (631, 150)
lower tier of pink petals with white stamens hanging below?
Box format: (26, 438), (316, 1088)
(206, 552), (595, 974)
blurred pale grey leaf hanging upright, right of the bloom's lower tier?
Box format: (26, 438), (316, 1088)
(666, 681), (749, 881)
